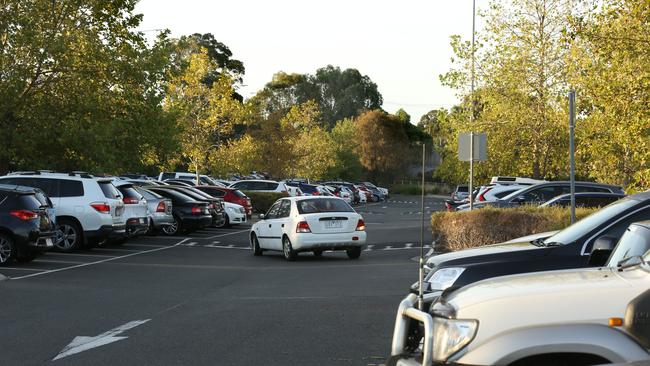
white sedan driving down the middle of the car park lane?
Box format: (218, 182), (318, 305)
(250, 196), (366, 261)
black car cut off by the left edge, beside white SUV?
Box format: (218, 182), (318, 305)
(0, 184), (55, 266)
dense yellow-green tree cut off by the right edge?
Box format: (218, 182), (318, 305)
(569, 0), (650, 191)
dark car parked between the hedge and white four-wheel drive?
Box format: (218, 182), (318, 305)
(424, 191), (650, 292)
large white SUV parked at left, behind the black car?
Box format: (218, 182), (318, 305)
(0, 172), (126, 251)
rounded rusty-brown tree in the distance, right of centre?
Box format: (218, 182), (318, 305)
(356, 110), (409, 181)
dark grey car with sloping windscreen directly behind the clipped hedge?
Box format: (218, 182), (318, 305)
(457, 181), (625, 211)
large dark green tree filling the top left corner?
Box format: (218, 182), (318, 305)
(0, 0), (174, 173)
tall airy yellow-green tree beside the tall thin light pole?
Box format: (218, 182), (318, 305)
(441, 0), (574, 178)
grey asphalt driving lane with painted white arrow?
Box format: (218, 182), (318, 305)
(0, 196), (443, 365)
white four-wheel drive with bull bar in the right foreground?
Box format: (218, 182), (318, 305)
(389, 221), (650, 365)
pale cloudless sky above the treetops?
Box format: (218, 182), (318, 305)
(136, 0), (479, 123)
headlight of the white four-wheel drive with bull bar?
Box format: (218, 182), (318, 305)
(432, 316), (478, 362)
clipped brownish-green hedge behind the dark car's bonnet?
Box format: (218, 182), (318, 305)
(431, 206), (597, 251)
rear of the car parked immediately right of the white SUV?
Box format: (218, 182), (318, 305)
(112, 180), (149, 243)
